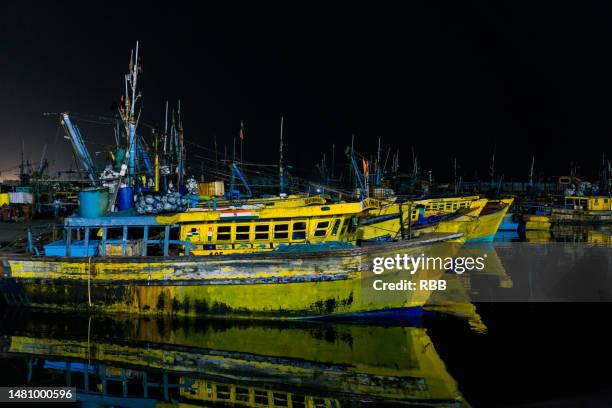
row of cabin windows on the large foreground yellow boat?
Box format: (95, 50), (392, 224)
(198, 219), (346, 241)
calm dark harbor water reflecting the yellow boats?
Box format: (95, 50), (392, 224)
(0, 228), (612, 407)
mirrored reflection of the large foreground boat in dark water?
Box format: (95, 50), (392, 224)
(0, 313), (468, 407)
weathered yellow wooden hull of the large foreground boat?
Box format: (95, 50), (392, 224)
(0, 235), (457, 318)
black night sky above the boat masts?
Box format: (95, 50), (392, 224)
(0, 1), (612, 179)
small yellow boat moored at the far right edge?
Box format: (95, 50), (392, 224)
(550, 196), (612, 224)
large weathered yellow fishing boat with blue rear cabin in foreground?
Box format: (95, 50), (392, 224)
(0, 200), (460, 318)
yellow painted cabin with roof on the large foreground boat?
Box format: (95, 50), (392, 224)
(156, 199), (377, 255)
